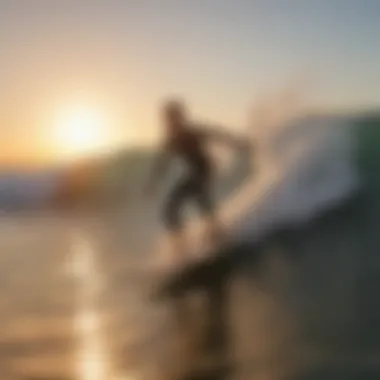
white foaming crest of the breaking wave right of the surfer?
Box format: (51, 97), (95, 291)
(225, 117), (361, 245)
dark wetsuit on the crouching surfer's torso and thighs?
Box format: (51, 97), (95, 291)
(163, 127), (214, 230)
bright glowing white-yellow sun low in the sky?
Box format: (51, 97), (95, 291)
(53, 106), (110, 159)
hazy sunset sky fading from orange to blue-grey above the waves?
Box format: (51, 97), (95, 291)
(0, 0), (380, 163)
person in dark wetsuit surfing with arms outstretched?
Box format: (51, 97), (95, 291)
(146, 99), (248, 262)
